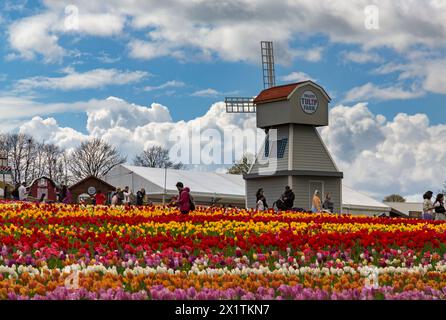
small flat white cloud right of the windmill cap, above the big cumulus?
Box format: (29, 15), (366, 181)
(345, 82), (425, 102)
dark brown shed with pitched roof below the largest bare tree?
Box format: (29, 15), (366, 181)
(68, 176), (116, 203)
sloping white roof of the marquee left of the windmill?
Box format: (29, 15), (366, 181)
(122, 165), (245, 197)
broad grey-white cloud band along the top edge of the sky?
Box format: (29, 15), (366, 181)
(9, 0), (446, 63)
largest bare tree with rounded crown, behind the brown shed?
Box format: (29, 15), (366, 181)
(69, 138), (126, 179)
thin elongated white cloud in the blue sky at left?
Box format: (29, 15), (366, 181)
(15, 68), (149, 91)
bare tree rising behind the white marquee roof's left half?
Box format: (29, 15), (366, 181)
(133, 146), (184, 169)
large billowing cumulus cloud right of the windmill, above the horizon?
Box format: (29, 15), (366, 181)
(320, 104), (446, 201)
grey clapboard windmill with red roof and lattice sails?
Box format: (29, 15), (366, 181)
(225, 41), (343, 212)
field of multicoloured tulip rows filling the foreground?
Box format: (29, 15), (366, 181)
(0, 202), (446, 300)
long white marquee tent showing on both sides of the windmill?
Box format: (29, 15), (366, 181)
(105, 165), (390, 216)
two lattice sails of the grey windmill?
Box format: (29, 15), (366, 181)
(225, 41), (276, 113)
